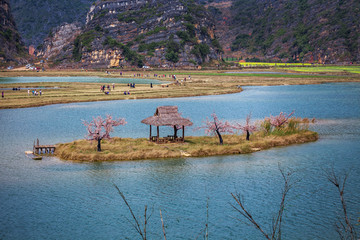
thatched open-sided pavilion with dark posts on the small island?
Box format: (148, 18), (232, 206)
(141, 106), (193, 143)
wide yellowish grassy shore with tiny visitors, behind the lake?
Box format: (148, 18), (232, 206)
(0, 68), (360, 109)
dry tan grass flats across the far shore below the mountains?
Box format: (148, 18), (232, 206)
(0, 70), (360, 109)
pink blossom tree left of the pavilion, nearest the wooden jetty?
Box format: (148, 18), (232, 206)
(83, 115), (127, 152)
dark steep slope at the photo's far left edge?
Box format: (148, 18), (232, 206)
(0, 0), (27, 64)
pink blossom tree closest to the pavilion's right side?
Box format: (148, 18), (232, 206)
(198, 113), (235, 145)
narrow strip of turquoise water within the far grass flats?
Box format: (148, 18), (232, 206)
(0, 77), (163, 84)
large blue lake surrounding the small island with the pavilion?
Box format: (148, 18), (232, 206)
(0, 83), (360, 239)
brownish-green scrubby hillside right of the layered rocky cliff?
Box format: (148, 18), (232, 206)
(222, 0), (360, 63)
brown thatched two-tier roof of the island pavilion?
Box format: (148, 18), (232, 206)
(141, 106), (193, 126)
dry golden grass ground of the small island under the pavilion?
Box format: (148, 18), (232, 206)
(56, 130), (318, 161)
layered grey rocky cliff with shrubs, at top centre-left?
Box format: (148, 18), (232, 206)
(67, 0), (221, 67)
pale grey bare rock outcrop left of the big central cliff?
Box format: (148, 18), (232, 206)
(36, 23), (81, 59)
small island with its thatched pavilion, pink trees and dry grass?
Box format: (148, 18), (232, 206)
(55, 106), (318, 162)
